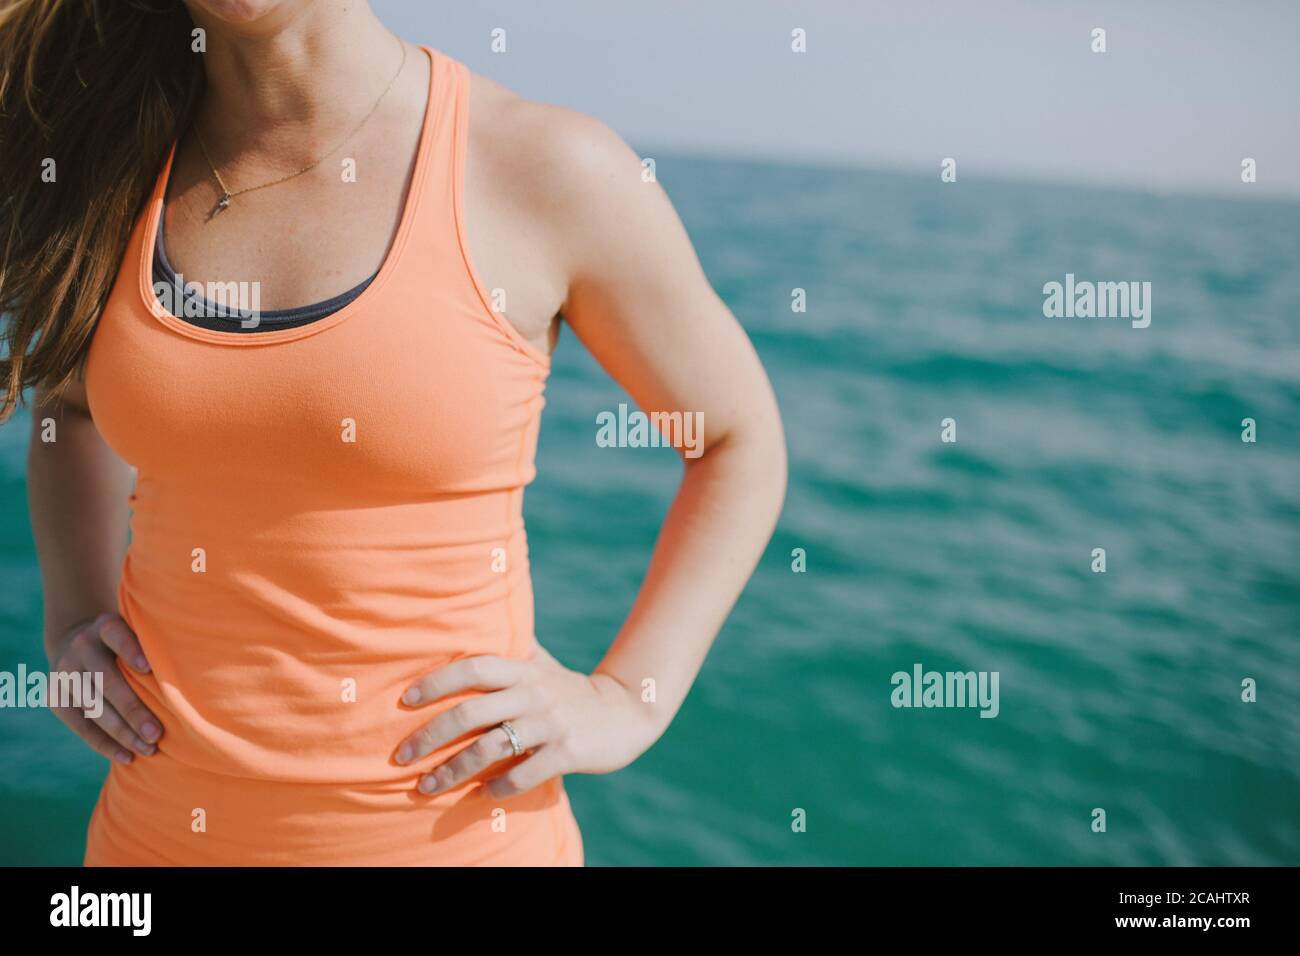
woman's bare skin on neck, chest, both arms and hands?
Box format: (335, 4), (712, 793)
(29, 0), (785, 796)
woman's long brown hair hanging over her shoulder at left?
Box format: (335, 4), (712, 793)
(0, 0), (203, 421)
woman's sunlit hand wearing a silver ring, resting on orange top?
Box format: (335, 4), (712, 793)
(397, 645), (659, 797)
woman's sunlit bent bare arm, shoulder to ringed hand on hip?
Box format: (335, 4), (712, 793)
(398, 108), (785, 796)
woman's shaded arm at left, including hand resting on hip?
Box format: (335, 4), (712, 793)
(27, 384), (163, 762)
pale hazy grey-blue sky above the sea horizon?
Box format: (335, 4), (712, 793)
(374, 0), (1300, 196)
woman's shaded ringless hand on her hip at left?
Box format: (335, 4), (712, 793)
(52, 614), (163, 763)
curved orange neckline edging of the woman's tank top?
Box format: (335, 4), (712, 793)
(138, 43), (438, 346)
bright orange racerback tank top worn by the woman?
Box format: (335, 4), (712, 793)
(86, 48), (582, 865)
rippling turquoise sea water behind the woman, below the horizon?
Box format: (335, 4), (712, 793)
(0, 156), (1300, 865)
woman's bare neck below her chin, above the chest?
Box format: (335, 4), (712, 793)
(191, 0), (402, 160)
